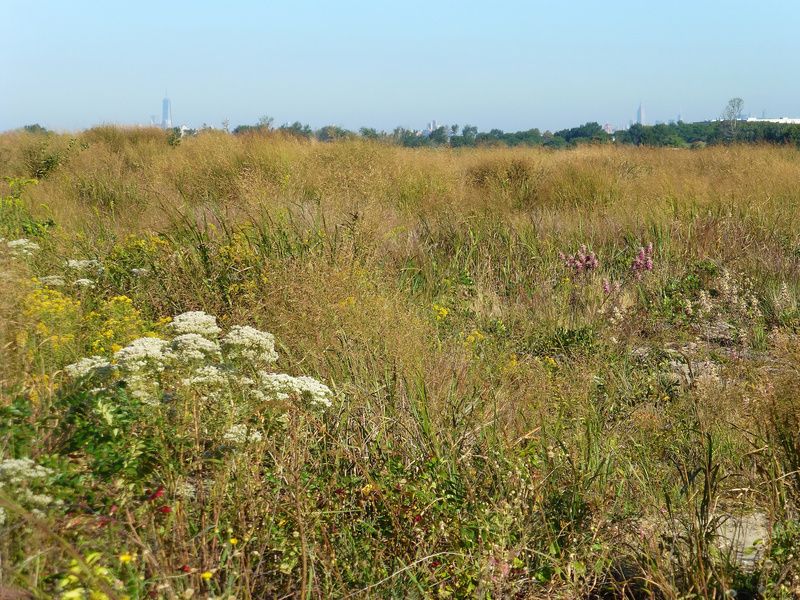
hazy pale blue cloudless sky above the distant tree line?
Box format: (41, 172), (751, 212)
(0, 0), (800, 130)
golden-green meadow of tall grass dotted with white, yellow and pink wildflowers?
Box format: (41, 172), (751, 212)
(0, 127), (800, 600)
